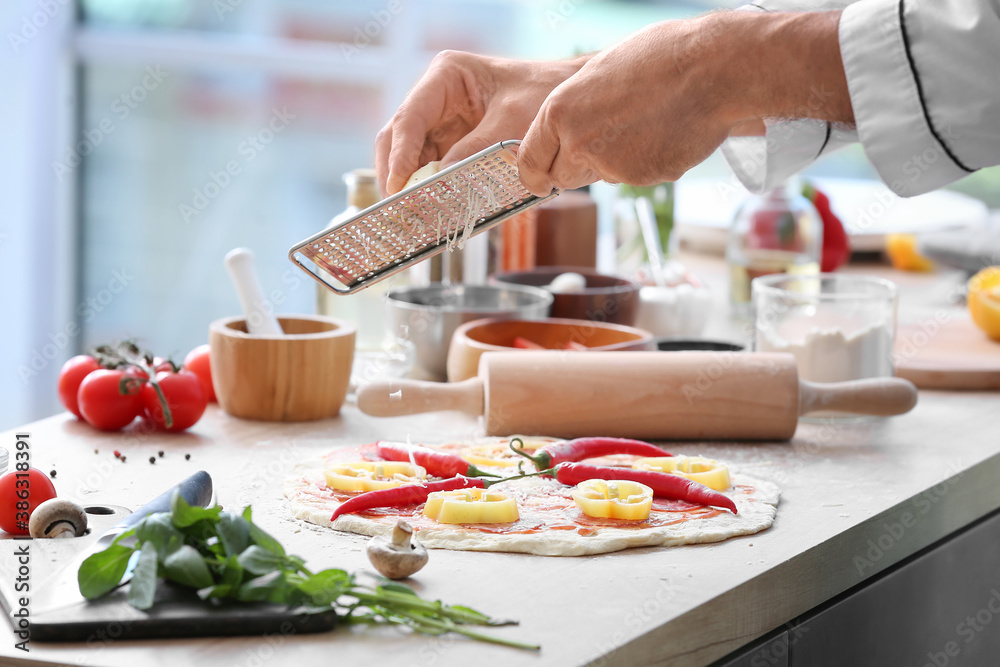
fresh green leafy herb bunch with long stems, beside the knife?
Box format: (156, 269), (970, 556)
(77, 491), (539, 650)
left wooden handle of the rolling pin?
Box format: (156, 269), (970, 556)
(358, 377), (484, 417)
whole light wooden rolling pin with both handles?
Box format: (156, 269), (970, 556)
(358, 350), (917, 440)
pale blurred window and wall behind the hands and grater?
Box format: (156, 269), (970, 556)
(0, 0), (1000, 428)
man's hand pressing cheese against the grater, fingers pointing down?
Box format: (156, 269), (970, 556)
(375, 51), (586, 195)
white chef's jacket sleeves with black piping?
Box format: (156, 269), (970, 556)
(723, 0), (1000, 196)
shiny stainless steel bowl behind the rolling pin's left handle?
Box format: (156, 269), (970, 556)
(386, 283), (552, 380)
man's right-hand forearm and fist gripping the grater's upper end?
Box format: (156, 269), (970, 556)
(518, 12), (853, 196)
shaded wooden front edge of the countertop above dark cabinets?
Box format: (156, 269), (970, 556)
(588, 454), (1000, 667)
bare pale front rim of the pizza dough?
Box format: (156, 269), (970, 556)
(284, 464), (781, 556)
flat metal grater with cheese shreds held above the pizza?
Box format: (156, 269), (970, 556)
(288, 141), (559, 294)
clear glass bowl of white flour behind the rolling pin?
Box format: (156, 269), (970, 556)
(752, 273), (897, 382)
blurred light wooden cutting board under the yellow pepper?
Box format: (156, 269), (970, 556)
(896, 313), (1000, 390)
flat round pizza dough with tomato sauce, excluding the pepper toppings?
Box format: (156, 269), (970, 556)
(284, 438), (780, 556)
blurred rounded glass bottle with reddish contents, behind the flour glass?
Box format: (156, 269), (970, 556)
(726, 179), (823, 316)
